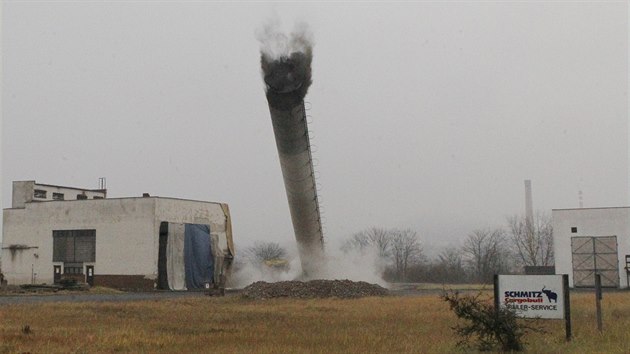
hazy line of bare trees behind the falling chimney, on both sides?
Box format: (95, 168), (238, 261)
(245, 212), (554, 283)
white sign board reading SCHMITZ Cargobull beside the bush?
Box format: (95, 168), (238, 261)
(496, 275), (564, 319)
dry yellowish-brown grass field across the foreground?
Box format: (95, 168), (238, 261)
(0, 292), (630, 353)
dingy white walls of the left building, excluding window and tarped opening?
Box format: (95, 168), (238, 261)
(2, 197), (232, 284)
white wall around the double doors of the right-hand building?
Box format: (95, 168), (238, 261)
(552, 207), (630, 288)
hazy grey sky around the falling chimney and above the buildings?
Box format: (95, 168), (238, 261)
(2, 1), (629, 253)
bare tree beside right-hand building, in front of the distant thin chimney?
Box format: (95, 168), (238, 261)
(508, 212), (554, 266)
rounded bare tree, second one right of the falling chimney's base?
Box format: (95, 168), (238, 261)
(391, 229), (422, 281)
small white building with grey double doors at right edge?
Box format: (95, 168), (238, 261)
(552, 207), (630, 288)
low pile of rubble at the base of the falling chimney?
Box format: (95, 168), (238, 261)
(242, 280), (389, 300)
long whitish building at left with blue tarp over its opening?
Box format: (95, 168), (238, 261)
(1, 181), (234, 290)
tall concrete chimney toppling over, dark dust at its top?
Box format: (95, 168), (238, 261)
(261, 23), (324, 278)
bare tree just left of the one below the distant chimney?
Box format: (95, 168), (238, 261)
(462, 229), (509, 283)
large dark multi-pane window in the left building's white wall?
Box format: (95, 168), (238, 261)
(53, 229), (96, 263)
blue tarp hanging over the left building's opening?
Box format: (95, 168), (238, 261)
(184, 224), (214, 289)
